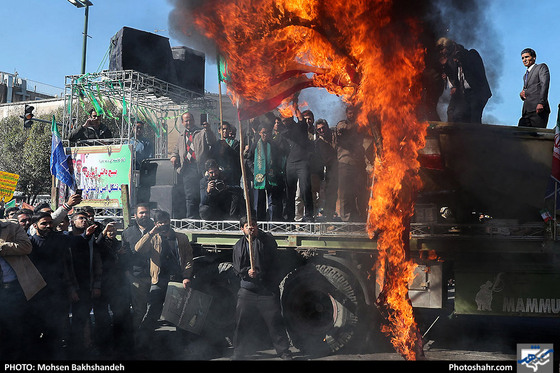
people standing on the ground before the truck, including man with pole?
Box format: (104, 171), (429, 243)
(0, 194), (292, 360)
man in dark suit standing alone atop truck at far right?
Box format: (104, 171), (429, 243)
(519, 48), (550, 128)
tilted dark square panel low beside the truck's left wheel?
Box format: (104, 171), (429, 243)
(161, 282), (212, 334)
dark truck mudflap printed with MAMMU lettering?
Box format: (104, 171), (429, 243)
(455, 271), (560, 317)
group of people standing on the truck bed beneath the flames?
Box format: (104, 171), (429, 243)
(170, 104), (373, 222)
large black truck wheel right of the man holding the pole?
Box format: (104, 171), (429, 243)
(280, 264), (365, 354)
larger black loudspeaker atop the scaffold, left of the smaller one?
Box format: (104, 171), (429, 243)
(109, 27), (177, 84)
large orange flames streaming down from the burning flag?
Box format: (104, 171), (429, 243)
(182, 0), (426, 360)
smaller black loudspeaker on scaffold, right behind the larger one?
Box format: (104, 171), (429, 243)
(171, 47), (205, 95)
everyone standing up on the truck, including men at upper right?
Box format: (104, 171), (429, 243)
(171, 43), (550, 222)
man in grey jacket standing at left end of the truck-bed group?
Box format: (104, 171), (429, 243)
(170, 113), (216, 219)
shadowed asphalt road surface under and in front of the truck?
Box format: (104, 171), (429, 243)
(145, 313), (560, 361)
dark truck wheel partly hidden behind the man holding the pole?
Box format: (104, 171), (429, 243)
(196, 262), (239, 343)
